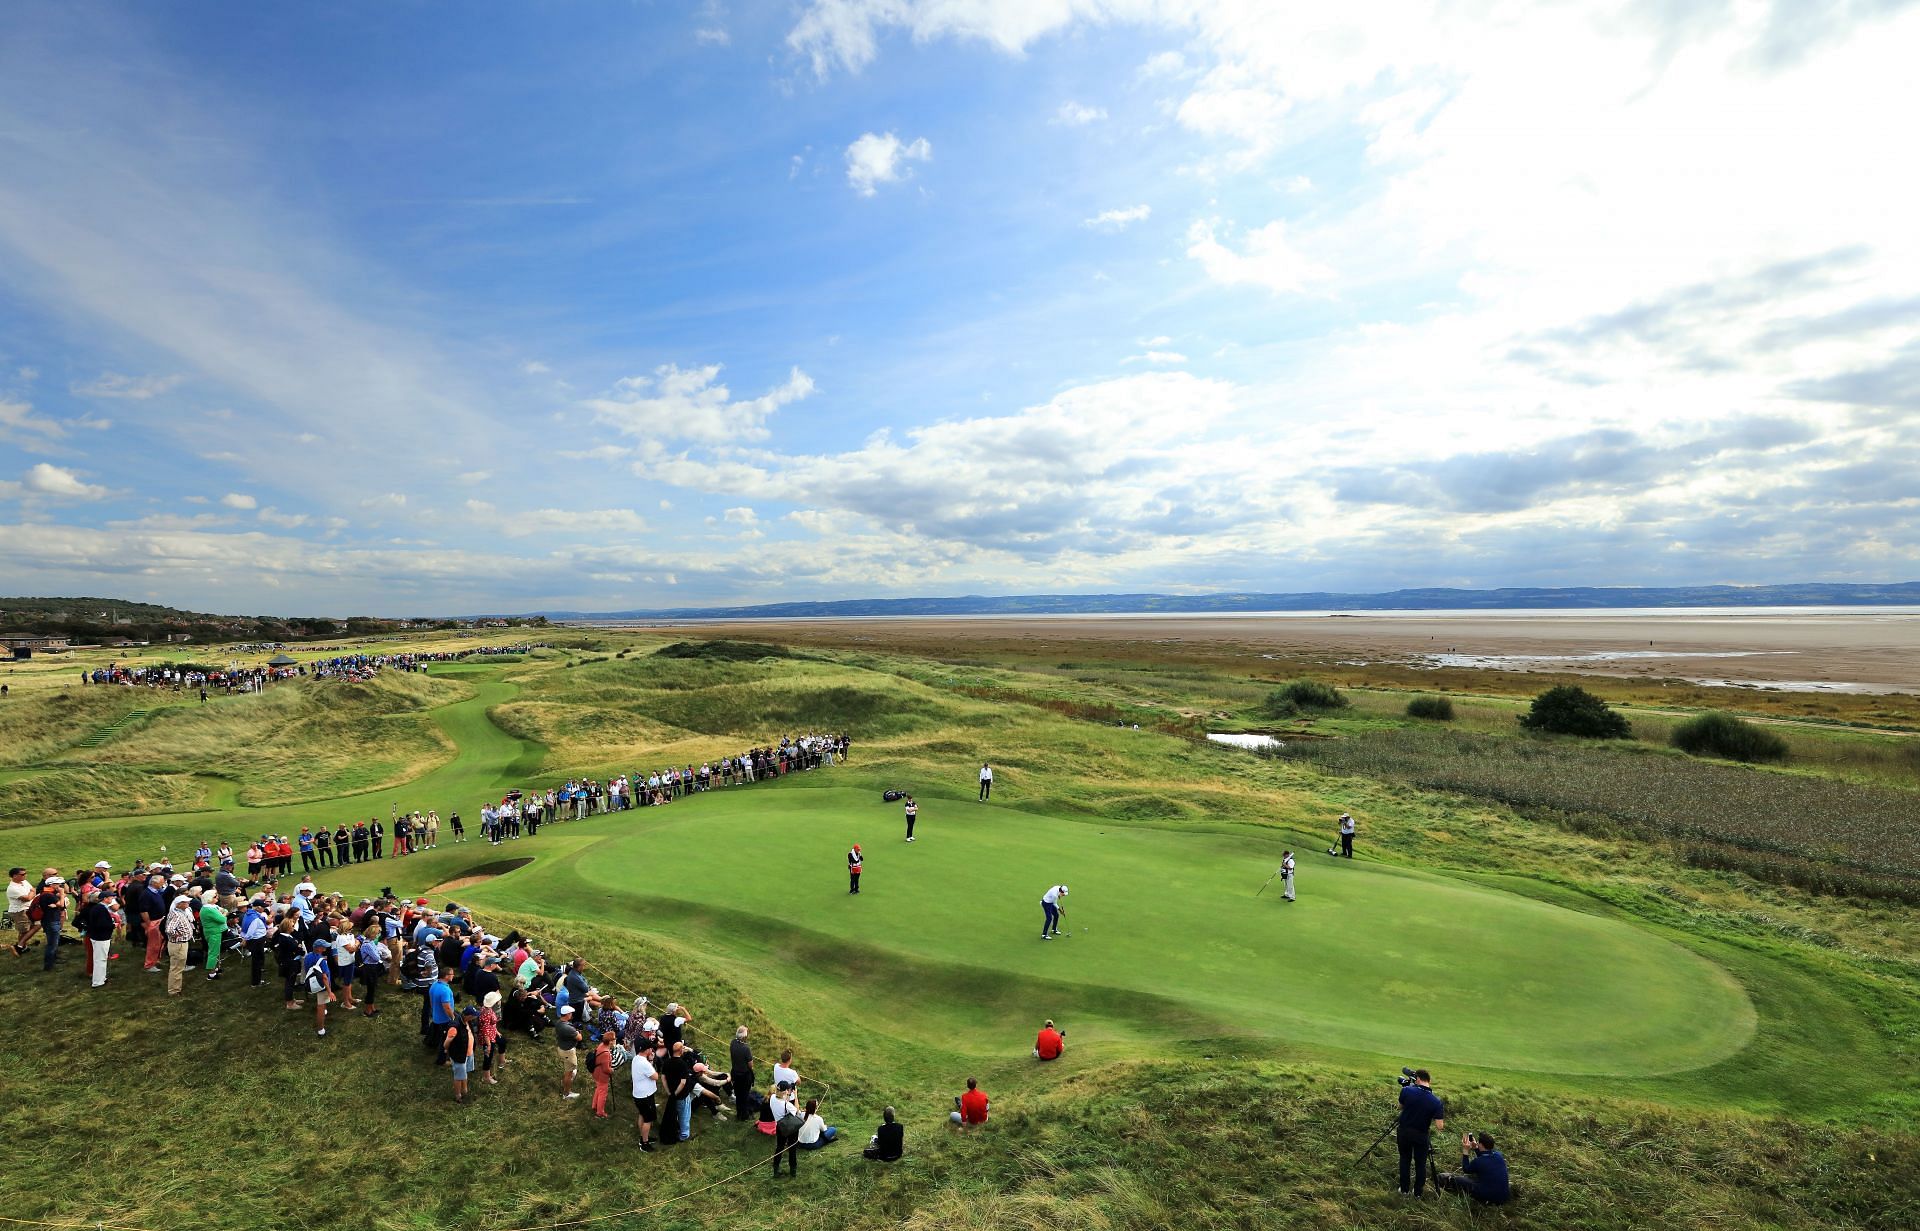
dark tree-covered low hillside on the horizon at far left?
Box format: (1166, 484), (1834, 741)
(0, 597), (545, 643)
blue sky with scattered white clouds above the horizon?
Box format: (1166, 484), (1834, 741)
(0, 0), (1920, 615)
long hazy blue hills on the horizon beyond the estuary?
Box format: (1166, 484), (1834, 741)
(541, 582), (1920, 620)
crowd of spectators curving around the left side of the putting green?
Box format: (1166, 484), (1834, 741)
(8, 736), (998, 1175)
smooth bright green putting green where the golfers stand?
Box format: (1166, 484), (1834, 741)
(445, 785), (1755, 1075)
